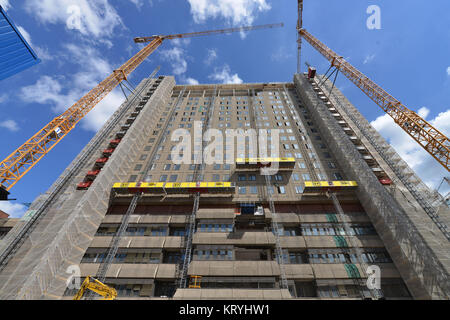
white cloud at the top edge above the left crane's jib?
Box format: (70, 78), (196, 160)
(187, 0), (271, 25)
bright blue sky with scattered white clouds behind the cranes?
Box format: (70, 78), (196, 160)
(0, 0), (450, 216)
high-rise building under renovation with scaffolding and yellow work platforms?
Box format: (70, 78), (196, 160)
(0, 74), (450, 299)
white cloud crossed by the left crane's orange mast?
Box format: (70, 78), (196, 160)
(20, 44), (125, 131)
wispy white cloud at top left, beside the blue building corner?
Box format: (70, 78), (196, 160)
(24, 0), (123, 38)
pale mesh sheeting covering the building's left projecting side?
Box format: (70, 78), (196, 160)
(0, 77), (174, 299)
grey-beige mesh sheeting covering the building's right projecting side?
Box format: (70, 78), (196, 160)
(294, 75), (450, 299)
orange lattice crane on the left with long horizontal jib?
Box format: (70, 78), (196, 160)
(0, 24), (283, 191)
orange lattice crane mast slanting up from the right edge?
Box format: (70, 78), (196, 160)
(299, 29), (450, 171)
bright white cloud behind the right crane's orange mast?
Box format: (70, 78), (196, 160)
(371, 107), (450, 192)
